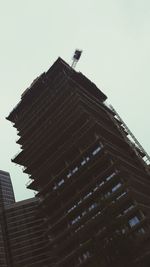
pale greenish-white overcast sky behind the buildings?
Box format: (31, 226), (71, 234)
(0, 0), (150, 200)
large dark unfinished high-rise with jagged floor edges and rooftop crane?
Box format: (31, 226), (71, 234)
(7, 58), (150, 267)
